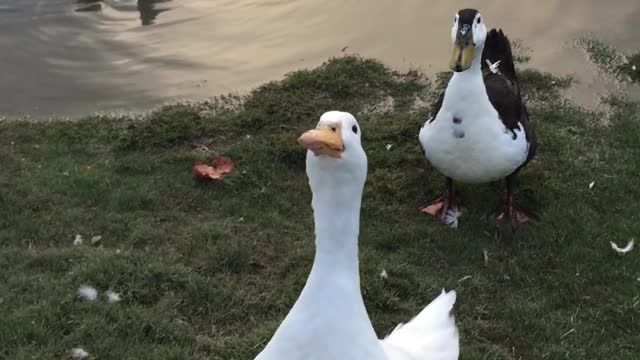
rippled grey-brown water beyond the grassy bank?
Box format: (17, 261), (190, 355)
(0, 0), (640, 117)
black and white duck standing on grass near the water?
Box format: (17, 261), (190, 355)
(419, 9), (536, 223)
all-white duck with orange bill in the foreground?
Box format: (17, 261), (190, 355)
(256, 111), (459, 360)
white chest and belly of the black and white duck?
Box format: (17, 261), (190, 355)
(419, 64), (529, 183)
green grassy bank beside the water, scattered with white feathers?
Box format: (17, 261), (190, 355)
(0, 49), (640, 360)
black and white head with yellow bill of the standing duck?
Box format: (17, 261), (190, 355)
(449, 9), (487, 72)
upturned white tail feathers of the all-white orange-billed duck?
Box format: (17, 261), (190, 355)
(381, 290), (460, 360)
